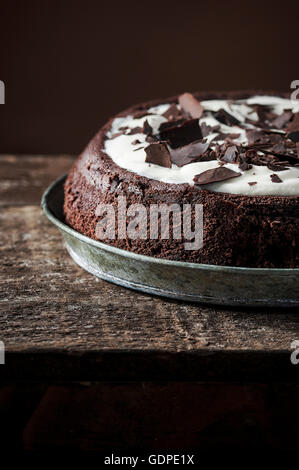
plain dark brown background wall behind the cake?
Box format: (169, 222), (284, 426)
(0, 0), (299, 153)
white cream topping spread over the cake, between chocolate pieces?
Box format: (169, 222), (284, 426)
(104, 96), (299, 196)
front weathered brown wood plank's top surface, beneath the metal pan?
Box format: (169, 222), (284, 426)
(0, 206), (299, 351)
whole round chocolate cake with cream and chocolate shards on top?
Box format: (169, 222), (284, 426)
(64, 92), (299, 268)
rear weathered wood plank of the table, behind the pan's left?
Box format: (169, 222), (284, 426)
(0, 155), (74, 206)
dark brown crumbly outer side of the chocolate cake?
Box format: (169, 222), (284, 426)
(64, 92), (299, 268)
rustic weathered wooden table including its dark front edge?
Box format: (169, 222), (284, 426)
(0, 155), (299, 382)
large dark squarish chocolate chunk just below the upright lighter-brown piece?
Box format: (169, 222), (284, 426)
(159, 119), (202, 148)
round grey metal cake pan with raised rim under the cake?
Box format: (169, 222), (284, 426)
(42, 175), (299, 307)
